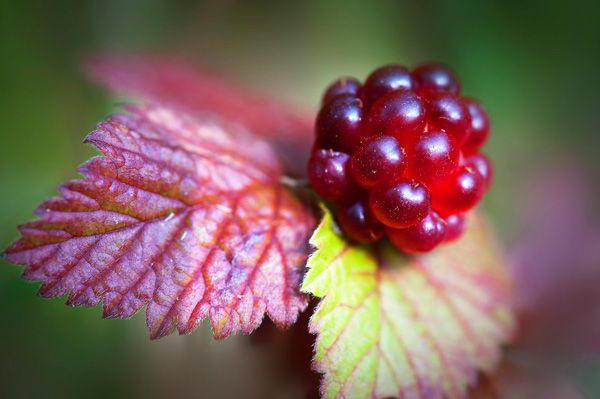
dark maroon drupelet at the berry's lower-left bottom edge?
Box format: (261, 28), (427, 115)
(337, 201), (383, 244)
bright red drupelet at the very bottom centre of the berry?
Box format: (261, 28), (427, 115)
(386, 212), (446, 253)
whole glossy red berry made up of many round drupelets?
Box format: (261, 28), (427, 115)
(308, 64), (492, 253)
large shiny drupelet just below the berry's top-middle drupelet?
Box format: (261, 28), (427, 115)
(368, 90), (425, 144)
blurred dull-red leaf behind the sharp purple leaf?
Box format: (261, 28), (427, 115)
(87, 55), (313, 175)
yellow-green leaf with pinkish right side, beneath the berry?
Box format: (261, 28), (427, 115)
(302, 209), (513, 399)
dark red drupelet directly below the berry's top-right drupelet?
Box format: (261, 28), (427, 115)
(427, 93), (471, 145)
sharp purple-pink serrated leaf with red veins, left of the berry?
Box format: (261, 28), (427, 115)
(5, 105), (314, 338)
